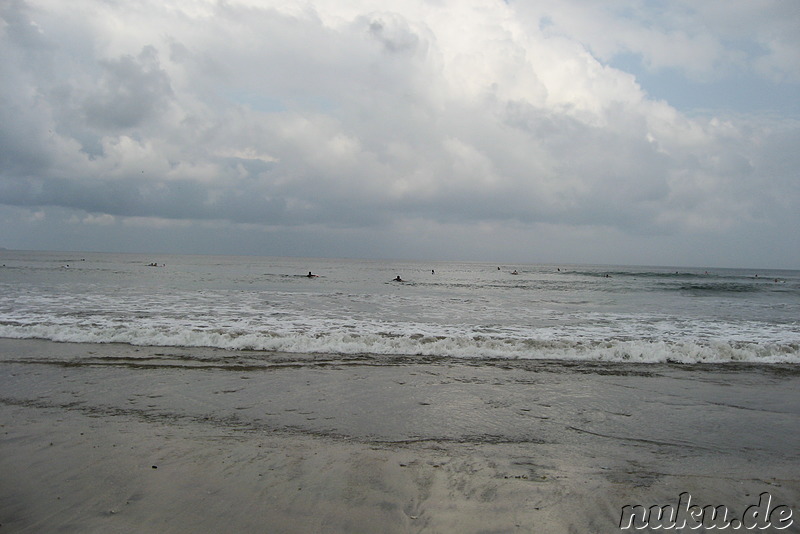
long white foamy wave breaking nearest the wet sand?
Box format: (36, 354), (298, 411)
(0, 324), (800, 364)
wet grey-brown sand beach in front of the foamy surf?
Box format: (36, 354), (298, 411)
(0, 339), (800, 533)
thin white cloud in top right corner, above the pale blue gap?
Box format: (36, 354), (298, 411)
(512, 0), (800, 83)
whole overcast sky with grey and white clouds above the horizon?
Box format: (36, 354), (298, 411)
(0, 0), (800, 268)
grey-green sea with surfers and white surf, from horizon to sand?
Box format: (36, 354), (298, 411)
(0, 250), (800, 363)
